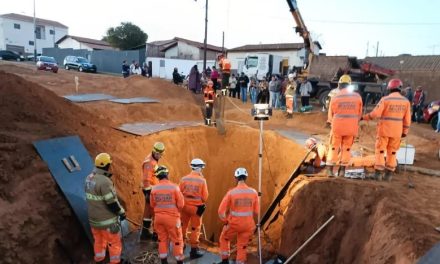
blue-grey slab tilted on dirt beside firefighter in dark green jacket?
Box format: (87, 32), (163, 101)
(33, 136), (93, 242)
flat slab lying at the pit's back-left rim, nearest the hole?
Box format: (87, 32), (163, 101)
(116, 121), (202, 136)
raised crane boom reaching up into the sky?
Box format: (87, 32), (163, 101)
(286, 0), (315, 76)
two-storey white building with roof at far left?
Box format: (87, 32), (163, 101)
(0, 13), (68, 54)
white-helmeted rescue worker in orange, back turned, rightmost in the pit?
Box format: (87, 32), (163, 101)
(218, 168), (259, 264)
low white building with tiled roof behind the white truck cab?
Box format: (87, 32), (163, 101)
(227, 43), (305, 73)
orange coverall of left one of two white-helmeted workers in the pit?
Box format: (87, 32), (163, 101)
(179, 171), (208, 248)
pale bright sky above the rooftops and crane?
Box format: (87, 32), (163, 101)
(0, 0), (440, 58)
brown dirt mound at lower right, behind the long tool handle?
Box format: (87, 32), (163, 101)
(267, 178), (439, 264)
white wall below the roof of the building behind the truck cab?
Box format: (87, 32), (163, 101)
(228, 49), (305, 70)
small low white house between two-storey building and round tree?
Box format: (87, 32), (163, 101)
(56, 35), (116, 51)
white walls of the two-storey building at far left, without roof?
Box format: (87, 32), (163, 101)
(0, 18), (68, 53)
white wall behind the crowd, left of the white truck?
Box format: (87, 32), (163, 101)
(147, 58), (215, 79)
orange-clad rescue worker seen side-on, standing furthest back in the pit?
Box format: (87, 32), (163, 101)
(140, 142), (165, 241)
